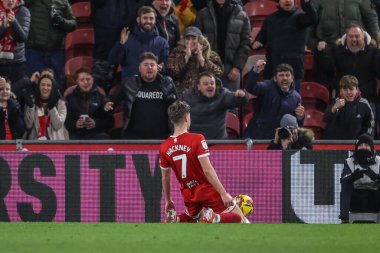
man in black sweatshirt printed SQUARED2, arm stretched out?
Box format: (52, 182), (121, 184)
(104, 52), (177, 139)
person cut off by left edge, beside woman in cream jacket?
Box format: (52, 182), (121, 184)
(0, 77), (25, 140)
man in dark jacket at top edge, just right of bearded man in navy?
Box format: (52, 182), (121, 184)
(152, 0), (180, 50)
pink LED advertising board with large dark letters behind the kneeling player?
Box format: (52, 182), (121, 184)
(0, 149), (349, 223)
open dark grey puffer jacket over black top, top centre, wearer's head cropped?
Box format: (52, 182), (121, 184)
(194, 1), (251, 70)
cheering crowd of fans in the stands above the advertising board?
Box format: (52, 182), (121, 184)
(0, 0), (380, 143)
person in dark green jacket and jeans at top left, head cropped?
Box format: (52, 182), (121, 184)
(25, 0), (77, 91)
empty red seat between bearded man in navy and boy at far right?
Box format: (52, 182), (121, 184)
(301, 82), (330, 112)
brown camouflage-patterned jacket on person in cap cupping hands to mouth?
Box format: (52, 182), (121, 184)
(167, 36), (224, 94)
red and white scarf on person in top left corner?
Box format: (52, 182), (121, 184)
(0, 0), (19, 60)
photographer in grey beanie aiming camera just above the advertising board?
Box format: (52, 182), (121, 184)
(267, 114), (314, 150)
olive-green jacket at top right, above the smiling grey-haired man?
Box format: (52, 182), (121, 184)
(309, 0), (380, 49)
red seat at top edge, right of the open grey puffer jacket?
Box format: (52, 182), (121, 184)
(244, 0), (277, 27)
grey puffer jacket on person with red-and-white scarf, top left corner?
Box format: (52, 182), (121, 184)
(0, 0), (30, 64)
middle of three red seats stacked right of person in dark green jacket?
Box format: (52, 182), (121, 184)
(65, 27), (95, 60)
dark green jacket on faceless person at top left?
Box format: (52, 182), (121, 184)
(25, 0), (77, 52)
